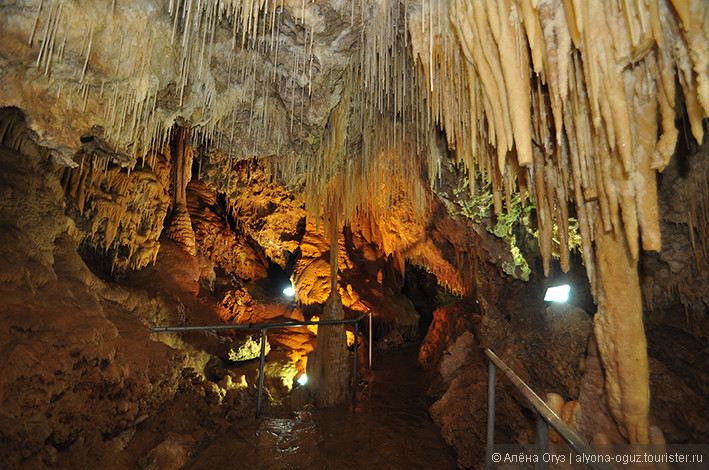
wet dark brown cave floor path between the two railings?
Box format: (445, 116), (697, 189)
(182, 347), (457, 470)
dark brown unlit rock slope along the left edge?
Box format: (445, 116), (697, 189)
(0, 105), (184, 468)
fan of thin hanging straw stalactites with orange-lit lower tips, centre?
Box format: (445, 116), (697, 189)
(292, 1), (437, 233)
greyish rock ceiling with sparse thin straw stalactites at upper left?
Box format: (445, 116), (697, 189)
(0, 1), (358, 169)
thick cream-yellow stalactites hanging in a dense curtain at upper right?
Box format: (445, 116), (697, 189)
(410, 0), (709, 294)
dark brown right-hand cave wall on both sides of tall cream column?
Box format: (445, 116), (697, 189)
(419, 131), (709, 468)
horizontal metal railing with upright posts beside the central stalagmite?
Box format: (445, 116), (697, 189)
(150, 310), (373, 418)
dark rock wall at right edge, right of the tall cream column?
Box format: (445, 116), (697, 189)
(639, 137), (709, 443)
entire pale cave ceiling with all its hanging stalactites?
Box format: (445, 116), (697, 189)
(0, 0), (709, 284)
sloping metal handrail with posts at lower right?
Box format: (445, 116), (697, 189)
(485, 348), (610, 470)
